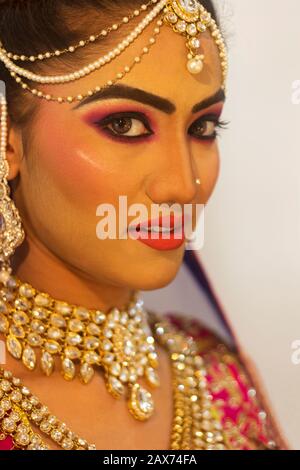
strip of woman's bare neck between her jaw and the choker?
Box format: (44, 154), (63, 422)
(11, 234), (133, 311)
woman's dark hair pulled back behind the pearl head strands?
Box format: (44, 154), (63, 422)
(0, 0), (216, 127)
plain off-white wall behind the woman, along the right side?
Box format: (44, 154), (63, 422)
(200, 0), (300, 449)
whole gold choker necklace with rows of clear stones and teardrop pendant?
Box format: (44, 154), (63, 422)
(0, 271), (160, 421)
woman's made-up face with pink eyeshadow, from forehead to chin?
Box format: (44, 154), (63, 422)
(9, 26), (223, 290)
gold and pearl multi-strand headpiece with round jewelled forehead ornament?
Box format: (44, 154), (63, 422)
(0, 0), (227, 103)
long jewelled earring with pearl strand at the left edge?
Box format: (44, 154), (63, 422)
(0, 86), (25, 272)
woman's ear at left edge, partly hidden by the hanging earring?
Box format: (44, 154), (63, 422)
(6, 117), (23, 180)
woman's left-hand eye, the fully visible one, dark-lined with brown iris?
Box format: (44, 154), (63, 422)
(95, 115), (153, 139)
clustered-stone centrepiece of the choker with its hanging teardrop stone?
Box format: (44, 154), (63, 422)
(100, 301), (159, 421)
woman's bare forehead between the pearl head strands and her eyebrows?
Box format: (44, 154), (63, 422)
(122, 27), (222, 103)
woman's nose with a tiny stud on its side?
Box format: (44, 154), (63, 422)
(147, 134), (199, 204)
